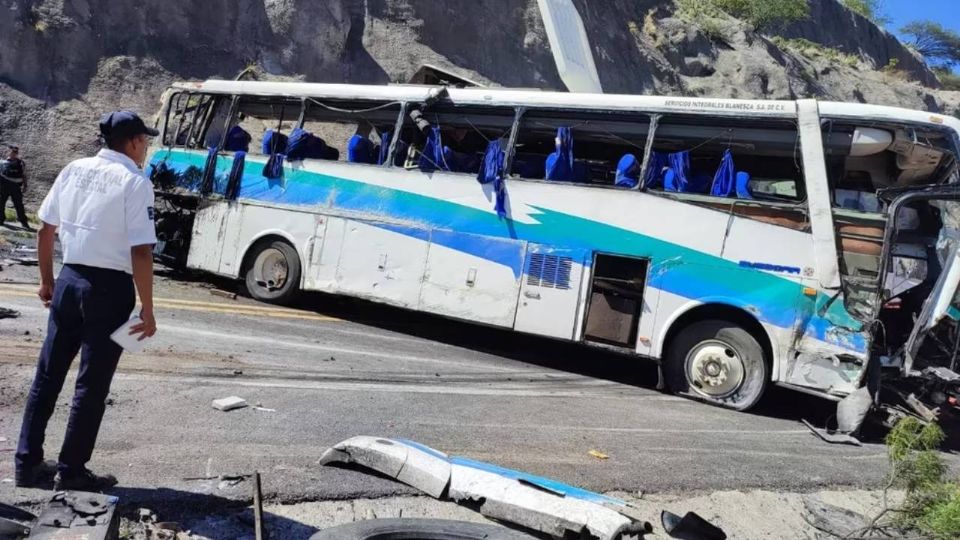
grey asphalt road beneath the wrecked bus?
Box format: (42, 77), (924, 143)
(0, 243), (953, 508)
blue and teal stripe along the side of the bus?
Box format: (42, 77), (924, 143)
(154, 151), (867, 353)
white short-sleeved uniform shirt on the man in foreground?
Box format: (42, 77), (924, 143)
(37, 149), (157, 274)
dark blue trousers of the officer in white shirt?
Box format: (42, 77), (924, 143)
(16, 264), (136, 474)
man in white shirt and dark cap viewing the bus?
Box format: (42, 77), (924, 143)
(16, 111), (157, 491)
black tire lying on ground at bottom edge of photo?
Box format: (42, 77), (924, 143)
(310, 518), (534, 540)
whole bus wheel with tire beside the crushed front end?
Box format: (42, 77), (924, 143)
(663, 319), (770, 411)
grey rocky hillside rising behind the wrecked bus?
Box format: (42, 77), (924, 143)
(0, 0), (960, 193)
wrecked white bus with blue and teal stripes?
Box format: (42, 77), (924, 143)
(149, 81), (960, 416)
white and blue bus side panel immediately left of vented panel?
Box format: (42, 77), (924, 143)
(420, 230), (526, 328)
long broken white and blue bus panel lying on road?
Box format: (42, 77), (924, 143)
(320, 437), (653, 540)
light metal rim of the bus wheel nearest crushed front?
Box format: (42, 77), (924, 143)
(686, 340), (746, 399)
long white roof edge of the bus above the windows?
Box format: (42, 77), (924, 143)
(172, 80), (960, 133)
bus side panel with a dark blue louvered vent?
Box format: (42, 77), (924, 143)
(514, 244), (585, 339)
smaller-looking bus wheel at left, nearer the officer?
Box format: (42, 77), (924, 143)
(244, 240), (300, 304)
